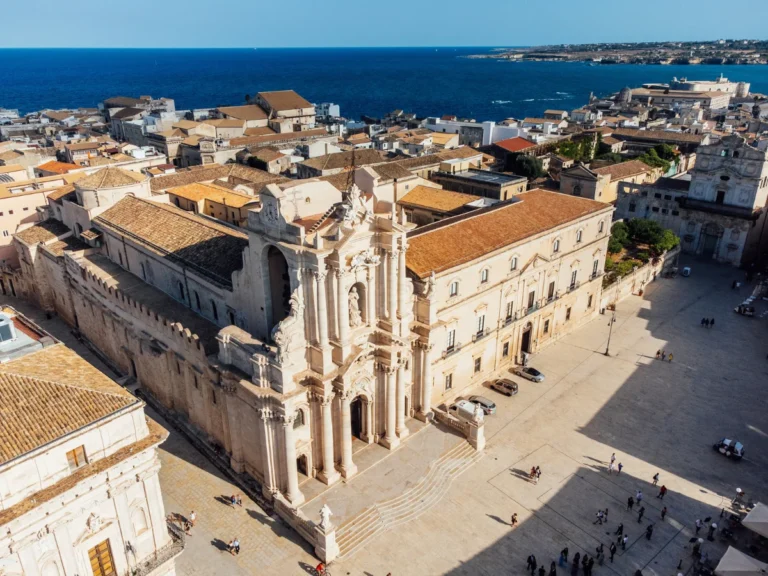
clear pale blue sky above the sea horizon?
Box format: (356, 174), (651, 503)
(0, 0), (768, 47)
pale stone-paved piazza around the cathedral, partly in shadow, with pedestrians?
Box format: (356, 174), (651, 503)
(9, 260), (768, 576)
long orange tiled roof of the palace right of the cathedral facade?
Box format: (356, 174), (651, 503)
(406, 190), (613, 278)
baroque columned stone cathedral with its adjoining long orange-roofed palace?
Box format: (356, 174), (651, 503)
(9, 156), (612, 558)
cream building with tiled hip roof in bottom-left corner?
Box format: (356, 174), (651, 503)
(0, 308), (179, 576)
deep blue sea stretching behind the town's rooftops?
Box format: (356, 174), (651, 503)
(0, 47), (768, 121)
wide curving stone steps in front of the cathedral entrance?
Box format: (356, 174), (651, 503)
(336, 442), (484, 559)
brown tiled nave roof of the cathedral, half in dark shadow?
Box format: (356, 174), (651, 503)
(93, 196), (248, 286)
